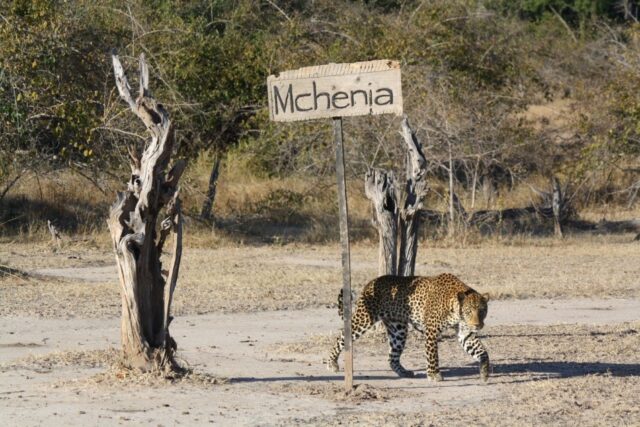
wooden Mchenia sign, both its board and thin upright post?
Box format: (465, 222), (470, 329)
(267, 59), (402, 391)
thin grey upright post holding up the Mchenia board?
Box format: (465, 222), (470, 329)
(333, 117), (353, 391)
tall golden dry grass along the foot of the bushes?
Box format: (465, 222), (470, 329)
(5, 161), (640, 248)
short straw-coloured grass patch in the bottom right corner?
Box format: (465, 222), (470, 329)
(298, 375), (640, 426)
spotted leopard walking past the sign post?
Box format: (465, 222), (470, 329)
(326, 273), (490, 381)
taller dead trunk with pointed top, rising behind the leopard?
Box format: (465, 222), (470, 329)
(398, 117), (427, 276)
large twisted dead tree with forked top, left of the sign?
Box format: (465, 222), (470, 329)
(107, 54), (186, 371)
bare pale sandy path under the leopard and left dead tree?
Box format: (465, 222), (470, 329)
(0, 299), (640, 425)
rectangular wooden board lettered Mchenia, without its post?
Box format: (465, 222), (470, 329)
(267, 59), (402, 122)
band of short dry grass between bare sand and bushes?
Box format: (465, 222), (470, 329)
(0, 236), (640, 317)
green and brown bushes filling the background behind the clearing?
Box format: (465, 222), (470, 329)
(0, 0), (640, 241)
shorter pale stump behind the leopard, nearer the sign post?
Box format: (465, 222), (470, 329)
(364, 169), (398, 276)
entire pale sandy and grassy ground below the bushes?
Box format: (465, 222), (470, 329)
(0, 239), (640, 426)
